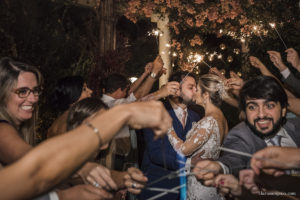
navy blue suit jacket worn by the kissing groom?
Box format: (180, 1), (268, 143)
(139, 101), (200, 200)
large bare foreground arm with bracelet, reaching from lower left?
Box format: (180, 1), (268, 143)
(0, 102), (171, 199)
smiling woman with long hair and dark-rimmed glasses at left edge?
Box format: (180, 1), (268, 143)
(0, 58), (42, 144)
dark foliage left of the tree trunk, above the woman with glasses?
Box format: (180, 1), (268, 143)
(0, 0), (101, 141)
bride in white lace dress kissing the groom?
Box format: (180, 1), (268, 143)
(168, 74), (228, 200)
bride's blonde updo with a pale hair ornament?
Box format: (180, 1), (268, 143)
(198, 74), (228, 106)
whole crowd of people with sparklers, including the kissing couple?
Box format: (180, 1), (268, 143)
(0, 48), (300, 200)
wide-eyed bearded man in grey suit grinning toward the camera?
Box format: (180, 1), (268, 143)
(194, 76), (300, 180)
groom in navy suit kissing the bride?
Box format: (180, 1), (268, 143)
(139, 71), (200, 200)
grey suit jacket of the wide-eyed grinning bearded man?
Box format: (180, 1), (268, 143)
(218, 117), (300, 176)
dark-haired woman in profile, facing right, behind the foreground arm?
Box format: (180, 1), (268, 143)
(47, 76), (93, 138)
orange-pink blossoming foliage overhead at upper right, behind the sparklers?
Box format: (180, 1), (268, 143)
(119, 0), (299, 79)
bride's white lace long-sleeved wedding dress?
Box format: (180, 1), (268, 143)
(168, 116), (223, 200)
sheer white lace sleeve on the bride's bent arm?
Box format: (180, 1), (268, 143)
(167, 117), (217, 156)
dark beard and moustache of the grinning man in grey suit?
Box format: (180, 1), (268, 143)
(246, 115), (282, 139)
